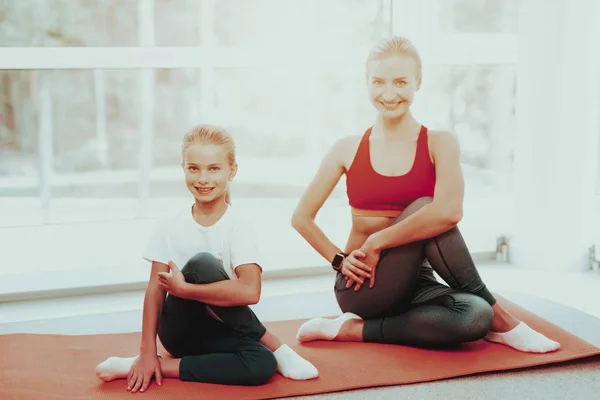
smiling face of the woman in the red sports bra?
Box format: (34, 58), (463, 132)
(367, 54), (421, 119)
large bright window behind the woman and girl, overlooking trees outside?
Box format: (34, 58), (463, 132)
(0, 0), (517, 290)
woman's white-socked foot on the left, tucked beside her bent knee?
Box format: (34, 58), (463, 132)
(296, 313), (364, 342)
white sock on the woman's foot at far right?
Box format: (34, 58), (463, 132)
(485, 322), (560, 353)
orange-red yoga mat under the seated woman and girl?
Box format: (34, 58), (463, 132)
(0, 297), (600, 400)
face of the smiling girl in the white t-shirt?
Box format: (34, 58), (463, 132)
(182, 142), (237, 203)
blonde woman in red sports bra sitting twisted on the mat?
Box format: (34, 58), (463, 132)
(292, 37), (559, 353)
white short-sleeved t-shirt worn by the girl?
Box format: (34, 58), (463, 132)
(142, 206), (262, 279)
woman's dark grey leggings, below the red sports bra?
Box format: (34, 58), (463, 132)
(335, 197), (496, 347)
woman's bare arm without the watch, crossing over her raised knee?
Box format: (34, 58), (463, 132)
(363, 132), (464, 251)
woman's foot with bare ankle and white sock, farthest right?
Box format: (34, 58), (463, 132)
(485, 303), (560, 353)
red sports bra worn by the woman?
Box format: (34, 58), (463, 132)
(346, 126), (435, 217)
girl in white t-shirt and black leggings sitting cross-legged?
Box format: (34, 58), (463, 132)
(96, 125), (318, 393)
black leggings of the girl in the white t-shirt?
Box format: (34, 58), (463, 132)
(158, 253), (277, 385)
